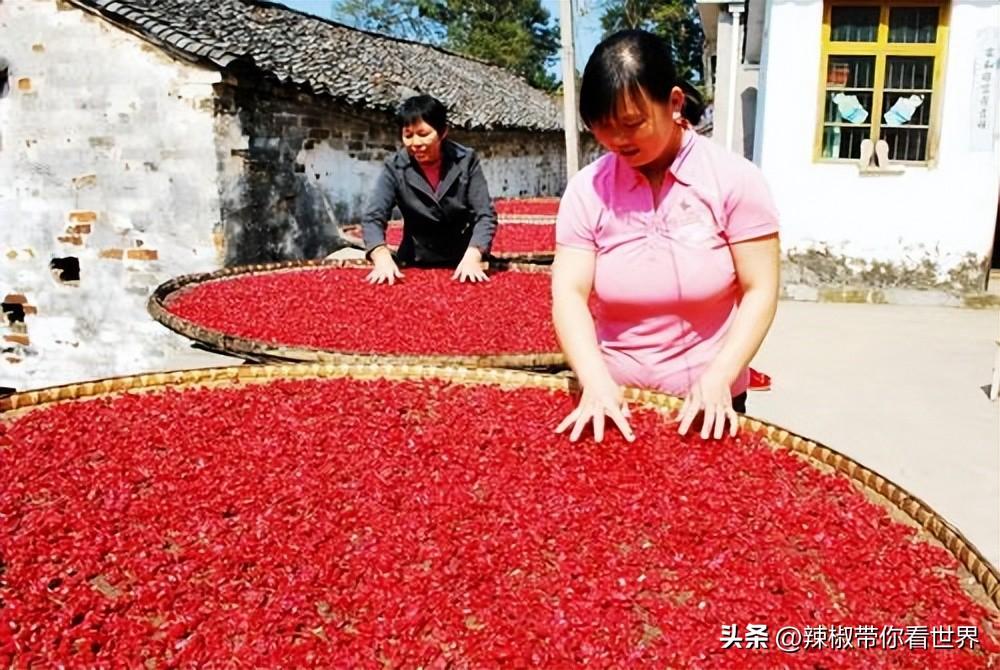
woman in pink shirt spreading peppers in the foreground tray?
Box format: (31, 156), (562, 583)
(552, 30), (779, 441)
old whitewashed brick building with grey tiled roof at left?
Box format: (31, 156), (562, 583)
(0, 0), (565, 389)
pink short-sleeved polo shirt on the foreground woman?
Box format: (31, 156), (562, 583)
(556, 130), (778, 395)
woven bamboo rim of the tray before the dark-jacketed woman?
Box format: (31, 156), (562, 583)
(146, 260), (566, 369)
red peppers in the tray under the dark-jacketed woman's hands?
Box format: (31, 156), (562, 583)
(166, 267), (559, 356)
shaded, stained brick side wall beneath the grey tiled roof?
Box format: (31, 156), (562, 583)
(216, 74), (597, 265)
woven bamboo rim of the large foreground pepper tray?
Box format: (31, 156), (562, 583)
(0, 359), (1000, 612)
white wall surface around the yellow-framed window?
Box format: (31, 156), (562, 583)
(758, 0), (1000, 273)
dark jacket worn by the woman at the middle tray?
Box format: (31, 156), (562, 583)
(361, 139), (497, 265)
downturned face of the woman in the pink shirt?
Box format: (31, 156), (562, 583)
(591, 86), (684, 168)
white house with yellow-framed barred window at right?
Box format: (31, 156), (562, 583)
(702, 0), (1000, 294)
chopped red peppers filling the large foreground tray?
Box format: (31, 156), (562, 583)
(0, 379), (1000, 670)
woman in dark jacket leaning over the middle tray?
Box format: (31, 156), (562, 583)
(362, 95), (497, 284)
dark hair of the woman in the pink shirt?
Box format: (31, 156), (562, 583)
(580, 30), (705, 127)
